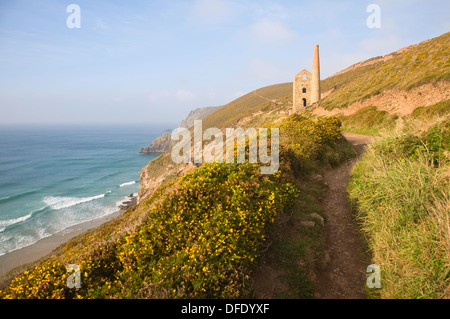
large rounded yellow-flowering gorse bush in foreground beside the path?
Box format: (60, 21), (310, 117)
(119, 164), (297, 298)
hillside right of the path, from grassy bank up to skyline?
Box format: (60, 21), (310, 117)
(314, 33), (450, 299)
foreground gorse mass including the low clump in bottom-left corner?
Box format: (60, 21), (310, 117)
(0, 163), (298, 298)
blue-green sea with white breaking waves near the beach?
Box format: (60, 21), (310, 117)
(0, 125), (167, 255)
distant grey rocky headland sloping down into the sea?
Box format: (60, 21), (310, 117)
(139, 106), (220, 154)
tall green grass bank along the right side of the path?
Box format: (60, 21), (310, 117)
(349, 119), (450, 298)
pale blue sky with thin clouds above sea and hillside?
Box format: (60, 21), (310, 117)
(0, 0), (450, 126)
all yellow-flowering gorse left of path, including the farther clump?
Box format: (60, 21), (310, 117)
(0, 116), (352, 298)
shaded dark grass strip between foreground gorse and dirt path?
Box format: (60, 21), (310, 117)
(256, 182), (325, 299)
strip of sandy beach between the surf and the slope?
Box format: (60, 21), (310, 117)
(0, 196), (137, 279)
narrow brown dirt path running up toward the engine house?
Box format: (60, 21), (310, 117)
(316, 133), (374, 299)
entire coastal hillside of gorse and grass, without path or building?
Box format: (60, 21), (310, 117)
(0, 33), (450, 298)
